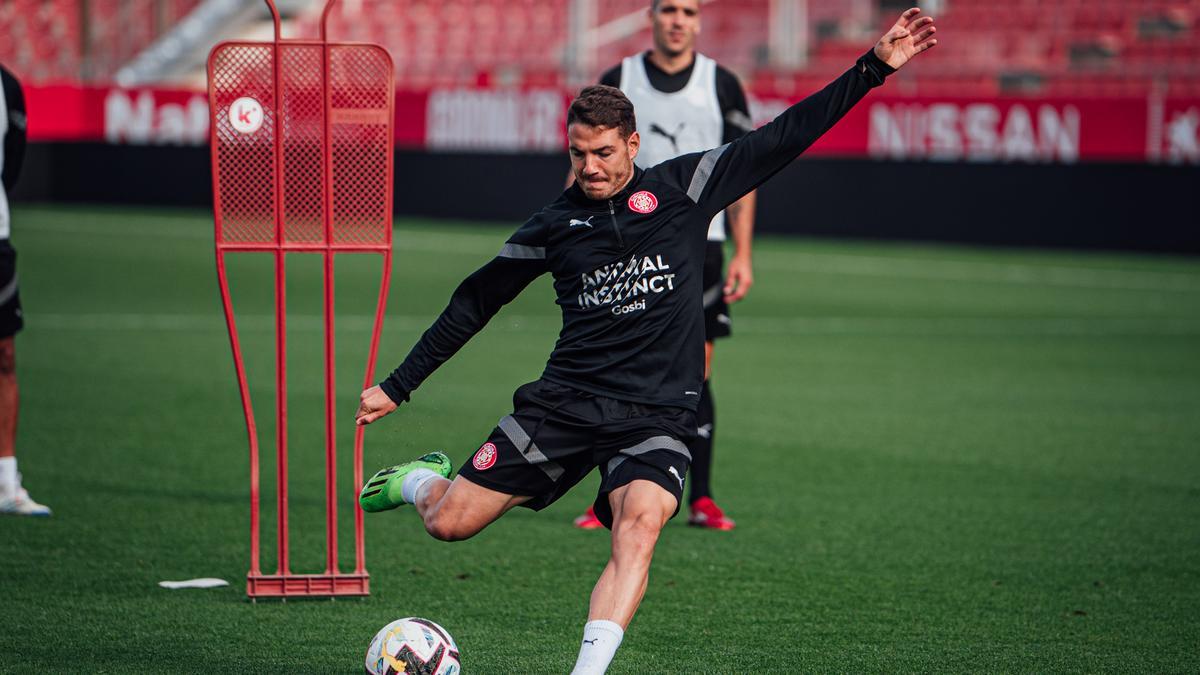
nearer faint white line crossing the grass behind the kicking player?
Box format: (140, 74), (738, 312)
(26, 313), (1200, 338)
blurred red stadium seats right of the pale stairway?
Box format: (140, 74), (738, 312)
(292, 0), (1200, 96)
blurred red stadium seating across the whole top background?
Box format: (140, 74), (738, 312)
(0, 0), (1200, 97)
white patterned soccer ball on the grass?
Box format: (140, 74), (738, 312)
(366, 616), (462, 675)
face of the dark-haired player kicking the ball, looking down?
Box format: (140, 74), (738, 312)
(566, 124), (641, 199)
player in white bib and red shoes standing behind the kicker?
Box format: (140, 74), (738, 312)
(575, 0), (755, 530)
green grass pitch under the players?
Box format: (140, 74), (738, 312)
(0, 201), (1200, 674)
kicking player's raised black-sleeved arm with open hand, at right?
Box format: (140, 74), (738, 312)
(665, 7), (937, 214)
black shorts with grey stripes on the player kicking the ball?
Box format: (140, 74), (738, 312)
(458, 380), (696, 528)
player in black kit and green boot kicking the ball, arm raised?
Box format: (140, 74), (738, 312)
(356, 8), (937, 674)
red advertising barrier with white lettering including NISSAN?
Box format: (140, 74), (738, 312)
(26, 86), (1200, 165)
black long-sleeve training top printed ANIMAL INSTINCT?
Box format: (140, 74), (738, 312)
(380, 50), (894, 410)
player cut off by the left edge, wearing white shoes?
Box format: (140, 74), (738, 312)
(0, 66), (50, 515)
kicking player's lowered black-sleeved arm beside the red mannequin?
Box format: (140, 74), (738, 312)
(354, 243), (546, 425)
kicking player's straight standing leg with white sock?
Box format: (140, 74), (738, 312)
(572, 480), (678, 675)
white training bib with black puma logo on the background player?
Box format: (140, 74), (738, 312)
(620, 53), (725, 241)
